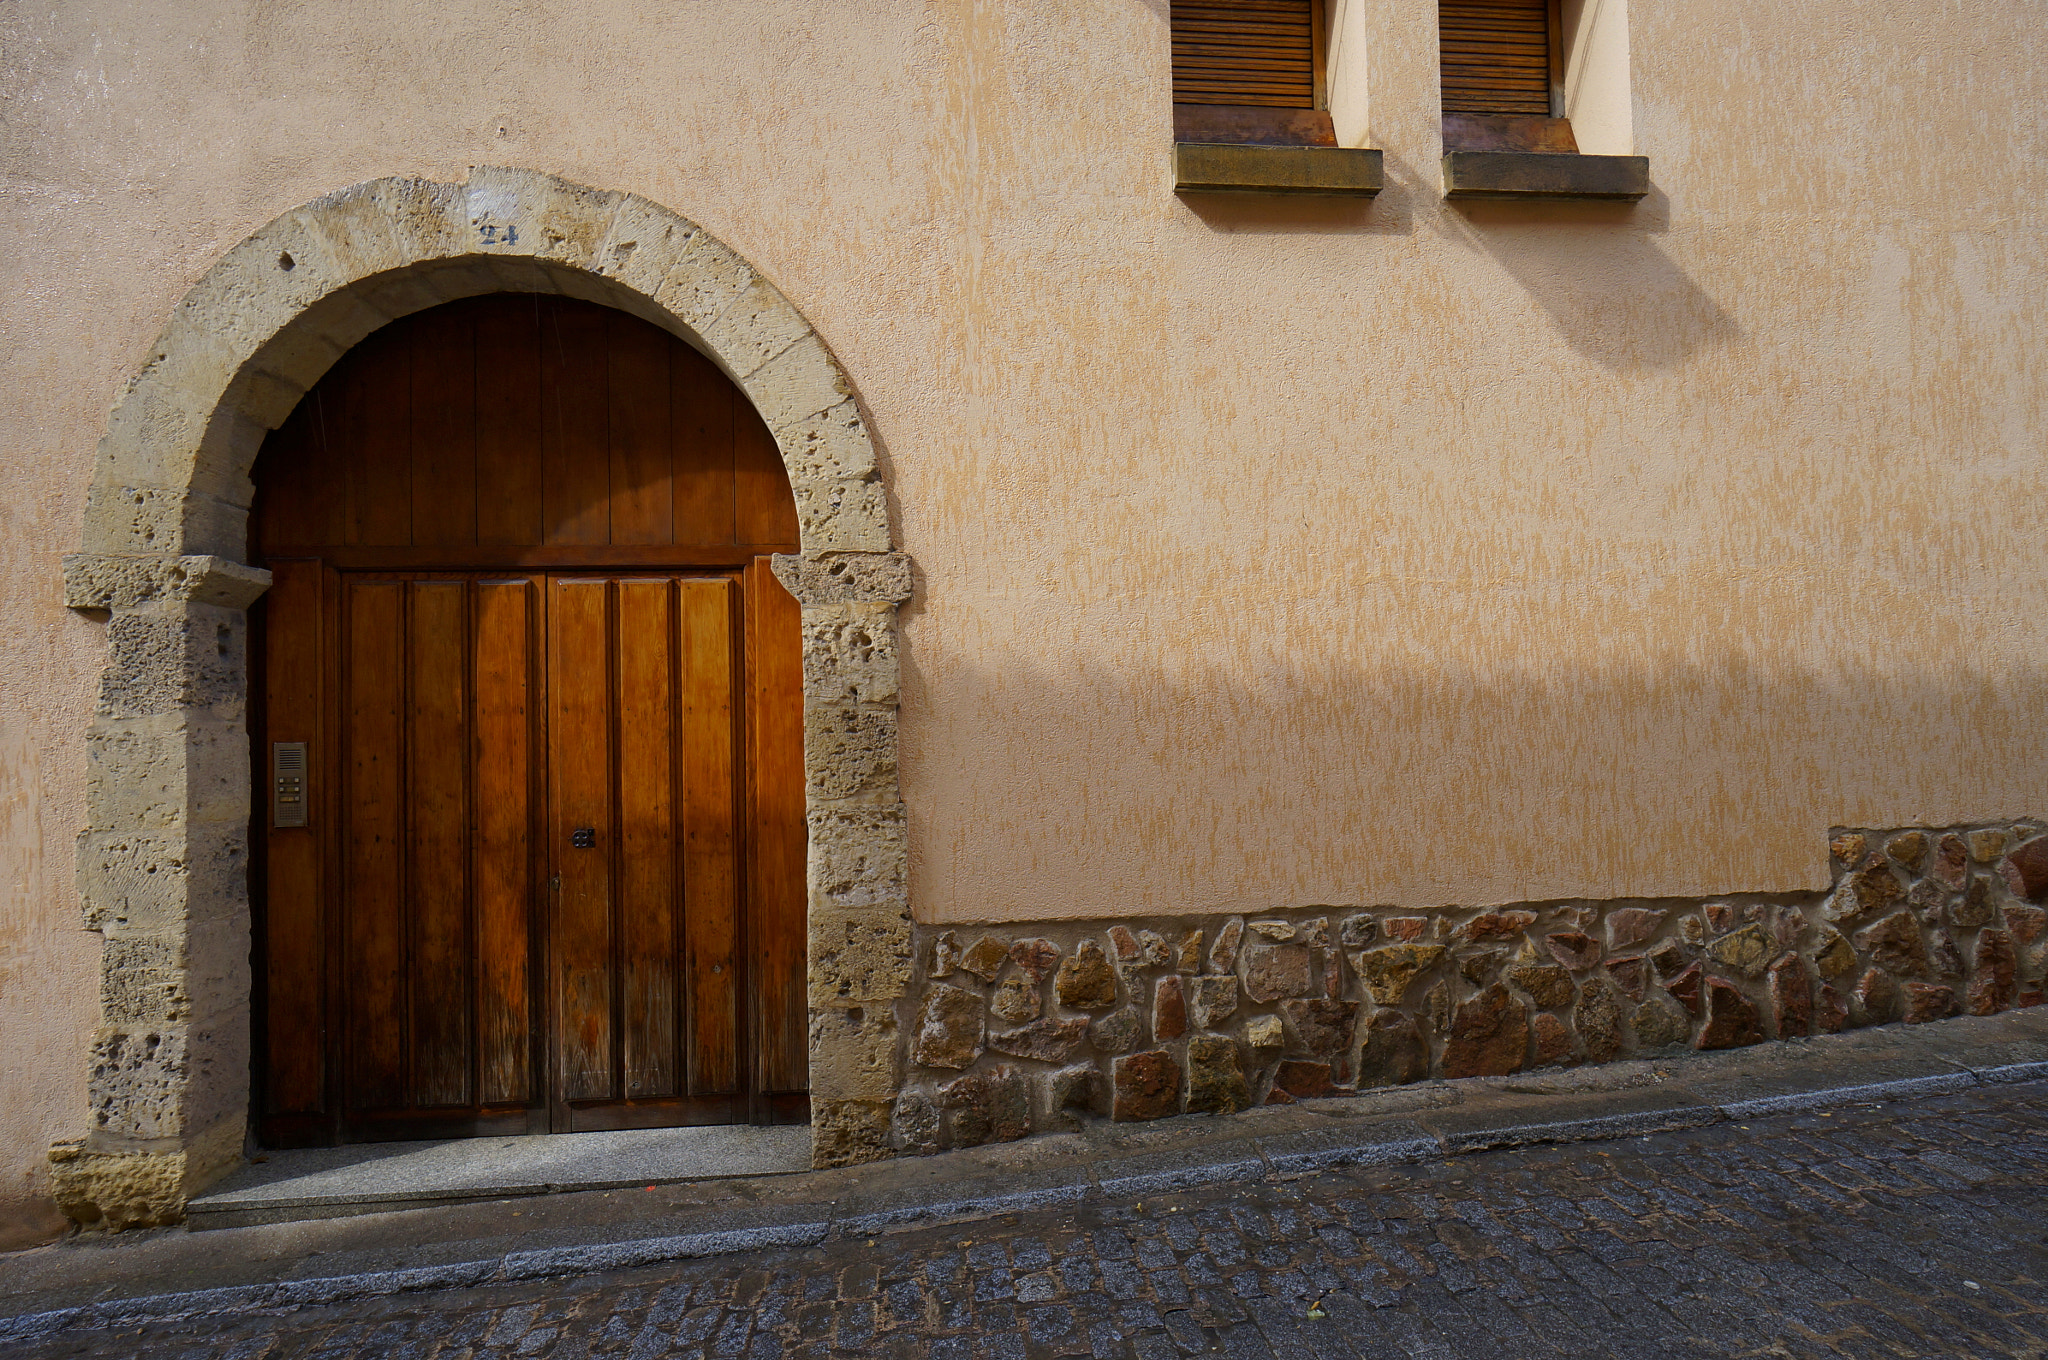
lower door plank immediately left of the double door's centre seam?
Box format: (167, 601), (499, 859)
(475, 580), (539, 1104)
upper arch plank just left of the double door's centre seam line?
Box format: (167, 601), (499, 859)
(475, 293), (545, 547)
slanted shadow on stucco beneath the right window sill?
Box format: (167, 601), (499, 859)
(1438, 190), (1743, 373)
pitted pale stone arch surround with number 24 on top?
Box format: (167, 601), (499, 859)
(51, 168), (911, 1227)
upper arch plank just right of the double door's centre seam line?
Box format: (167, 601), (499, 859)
(541, 305), (612, 543)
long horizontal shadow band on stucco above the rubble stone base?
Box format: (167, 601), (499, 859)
(903, 629), (2048, 924)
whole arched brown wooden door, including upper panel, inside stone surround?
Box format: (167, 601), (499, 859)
(252, 295), (809, 1147)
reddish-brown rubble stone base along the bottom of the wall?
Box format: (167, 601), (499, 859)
(891, 821), (2048, 1153)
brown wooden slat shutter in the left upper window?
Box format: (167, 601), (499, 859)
(1171, 0), (1315, 109)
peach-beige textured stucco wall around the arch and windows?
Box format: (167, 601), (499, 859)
(0, 0), (2048, 1229)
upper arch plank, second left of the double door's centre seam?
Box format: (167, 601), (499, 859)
(412, 307), (477, 547)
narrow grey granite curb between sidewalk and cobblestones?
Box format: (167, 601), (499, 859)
(0, 1032), (2048, 1346)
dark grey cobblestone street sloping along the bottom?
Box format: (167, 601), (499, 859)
(20, 1083), (2048, 1360)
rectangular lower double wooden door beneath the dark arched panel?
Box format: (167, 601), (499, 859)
(262, 559), (801, 1143)
